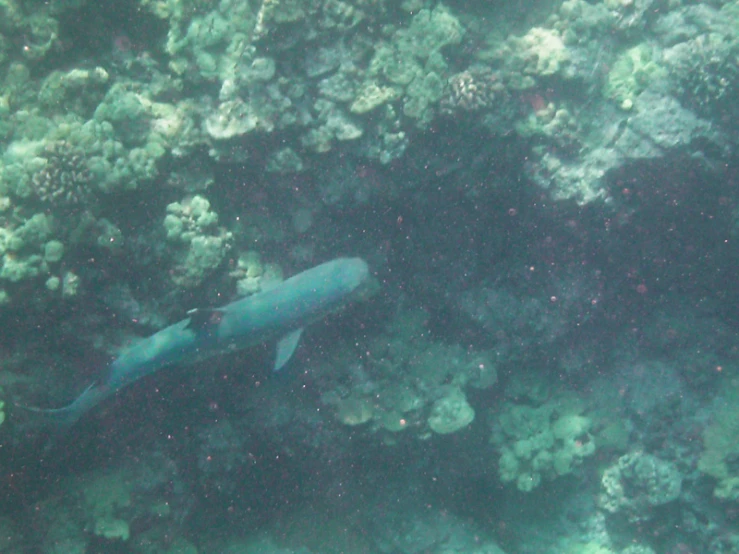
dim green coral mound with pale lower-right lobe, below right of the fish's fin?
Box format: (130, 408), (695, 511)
(319, 304), (497, 438)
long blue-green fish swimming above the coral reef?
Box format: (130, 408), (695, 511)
(24, 258), (376, 429)
